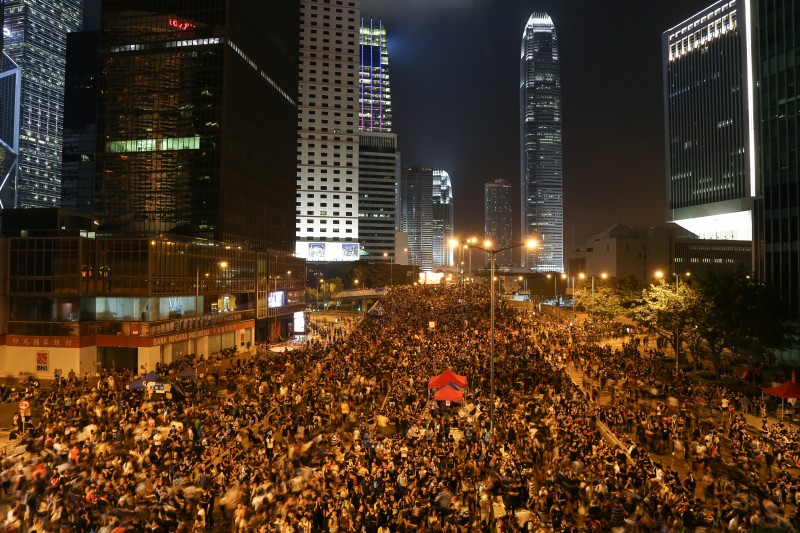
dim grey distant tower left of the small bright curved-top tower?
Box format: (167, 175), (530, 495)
(398, 166), (440, 271)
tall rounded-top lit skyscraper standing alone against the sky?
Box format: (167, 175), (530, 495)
(519, 13), (564, 272)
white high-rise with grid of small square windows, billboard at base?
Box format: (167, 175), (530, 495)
(292, 0), (361, 261)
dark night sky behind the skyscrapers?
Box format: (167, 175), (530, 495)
(86, 0), (711, 249)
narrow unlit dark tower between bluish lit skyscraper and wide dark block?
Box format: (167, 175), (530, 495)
(61, 31), (100, 213)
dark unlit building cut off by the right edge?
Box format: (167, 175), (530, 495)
(758, 0), (800, 316)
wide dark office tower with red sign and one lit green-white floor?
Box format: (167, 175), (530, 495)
(95, 0), (300, 252)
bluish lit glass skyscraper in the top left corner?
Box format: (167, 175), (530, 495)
(3, 0), (83, 207)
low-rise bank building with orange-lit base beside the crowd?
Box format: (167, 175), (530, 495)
(0, 209), (305, 379)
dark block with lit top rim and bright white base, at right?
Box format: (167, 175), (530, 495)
(662, 0), (759, 240)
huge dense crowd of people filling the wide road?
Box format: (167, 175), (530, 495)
(0, 284), (800, 533)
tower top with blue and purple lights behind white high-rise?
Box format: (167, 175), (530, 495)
(358, 17), (392, 133)
